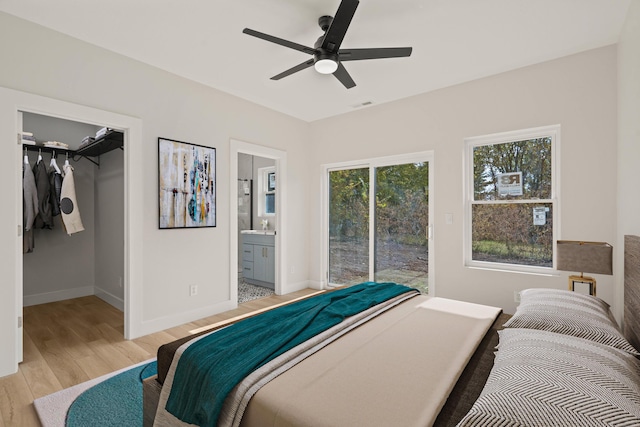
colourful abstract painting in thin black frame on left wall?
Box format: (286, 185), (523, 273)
(158, 138), (216, 229)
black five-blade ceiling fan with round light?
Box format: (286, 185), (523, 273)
(242, 0), (412, 89)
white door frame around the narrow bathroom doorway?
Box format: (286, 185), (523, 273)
(229, 139), (287, 305)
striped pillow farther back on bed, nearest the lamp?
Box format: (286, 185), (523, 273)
(504, 288), (640, 356)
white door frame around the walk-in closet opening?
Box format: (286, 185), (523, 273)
(0, 87), (144, 376)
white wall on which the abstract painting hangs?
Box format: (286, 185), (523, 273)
(0, 13), (309, 375)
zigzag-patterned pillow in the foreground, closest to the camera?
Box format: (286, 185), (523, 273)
(458, 328), (640, 427)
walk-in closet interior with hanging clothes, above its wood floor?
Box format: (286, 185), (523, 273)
(20, 112), (124, 324)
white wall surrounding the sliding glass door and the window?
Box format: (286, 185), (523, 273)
(309, 46), (620, 312)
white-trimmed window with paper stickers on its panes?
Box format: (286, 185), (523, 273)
(465, 125), (560, 272)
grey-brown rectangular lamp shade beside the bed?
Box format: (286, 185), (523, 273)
(557, 240), (613, 274)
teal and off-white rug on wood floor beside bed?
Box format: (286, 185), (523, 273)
(33, 360), (157, 427)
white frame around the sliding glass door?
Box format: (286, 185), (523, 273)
(320, 151), (435, 295)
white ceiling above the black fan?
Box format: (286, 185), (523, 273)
(0, 0), (633, 121)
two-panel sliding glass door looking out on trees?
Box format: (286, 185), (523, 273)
(327, 153), (430, 293)
